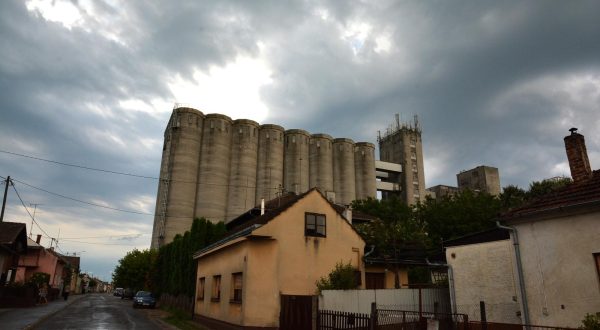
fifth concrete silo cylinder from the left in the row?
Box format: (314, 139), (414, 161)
(283, 129), (310, 194)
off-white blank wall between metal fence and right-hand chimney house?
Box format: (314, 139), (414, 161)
(446, 240), (522, 323)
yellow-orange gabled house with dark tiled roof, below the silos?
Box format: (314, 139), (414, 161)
(194, 189), (365, 328)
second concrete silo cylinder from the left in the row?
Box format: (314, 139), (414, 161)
(195, 113), (232, 222)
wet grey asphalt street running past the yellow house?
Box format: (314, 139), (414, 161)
(33, 294), (172, 330)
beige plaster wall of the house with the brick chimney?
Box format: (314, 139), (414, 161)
(515, 211), (600, 327)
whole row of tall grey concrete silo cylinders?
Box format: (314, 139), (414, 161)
(157, 108), (376, 226)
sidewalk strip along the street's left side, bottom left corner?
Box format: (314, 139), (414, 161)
(0, 294), (87, 329)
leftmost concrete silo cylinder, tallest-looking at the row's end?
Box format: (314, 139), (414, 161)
(151, 107), (204, 248)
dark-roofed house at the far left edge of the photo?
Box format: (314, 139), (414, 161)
(0, 222), (27, 285)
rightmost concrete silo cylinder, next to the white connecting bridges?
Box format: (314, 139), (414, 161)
(354, 142), (377, 199)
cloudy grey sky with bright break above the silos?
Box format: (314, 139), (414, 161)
(0, 0), (600, 280)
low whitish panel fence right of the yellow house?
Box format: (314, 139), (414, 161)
(319, 288), (451, 314)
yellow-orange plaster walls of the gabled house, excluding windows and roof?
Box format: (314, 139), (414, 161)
(195, 191), (364, 327)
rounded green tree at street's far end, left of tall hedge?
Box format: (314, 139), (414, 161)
(113, 249), (157, 290)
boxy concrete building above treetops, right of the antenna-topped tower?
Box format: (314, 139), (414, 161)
(456, 166), (501, 196)
